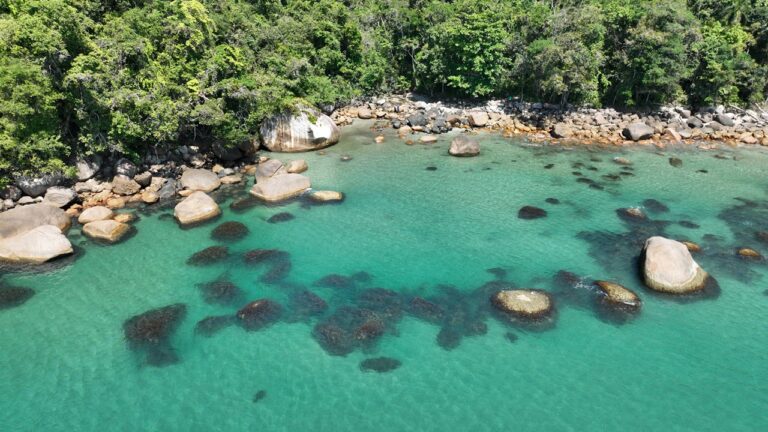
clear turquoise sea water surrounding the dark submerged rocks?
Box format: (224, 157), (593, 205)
(0, 123), (768, 431)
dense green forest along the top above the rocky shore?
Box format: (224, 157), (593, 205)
(0, 0), (768, 183)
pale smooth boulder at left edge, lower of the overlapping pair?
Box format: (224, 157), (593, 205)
(0, 225), (73, 264)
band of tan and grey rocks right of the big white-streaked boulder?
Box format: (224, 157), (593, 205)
(331, 96), (768, 146)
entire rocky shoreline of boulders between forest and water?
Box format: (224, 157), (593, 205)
(0, 95), (768, 246)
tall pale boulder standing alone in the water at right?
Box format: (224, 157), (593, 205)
(643, 236), (708, 294)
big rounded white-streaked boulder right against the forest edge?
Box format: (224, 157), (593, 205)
(259, 107), (340, 152)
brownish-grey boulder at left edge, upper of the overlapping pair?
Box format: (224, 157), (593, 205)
(0, 203), (72, 239)
